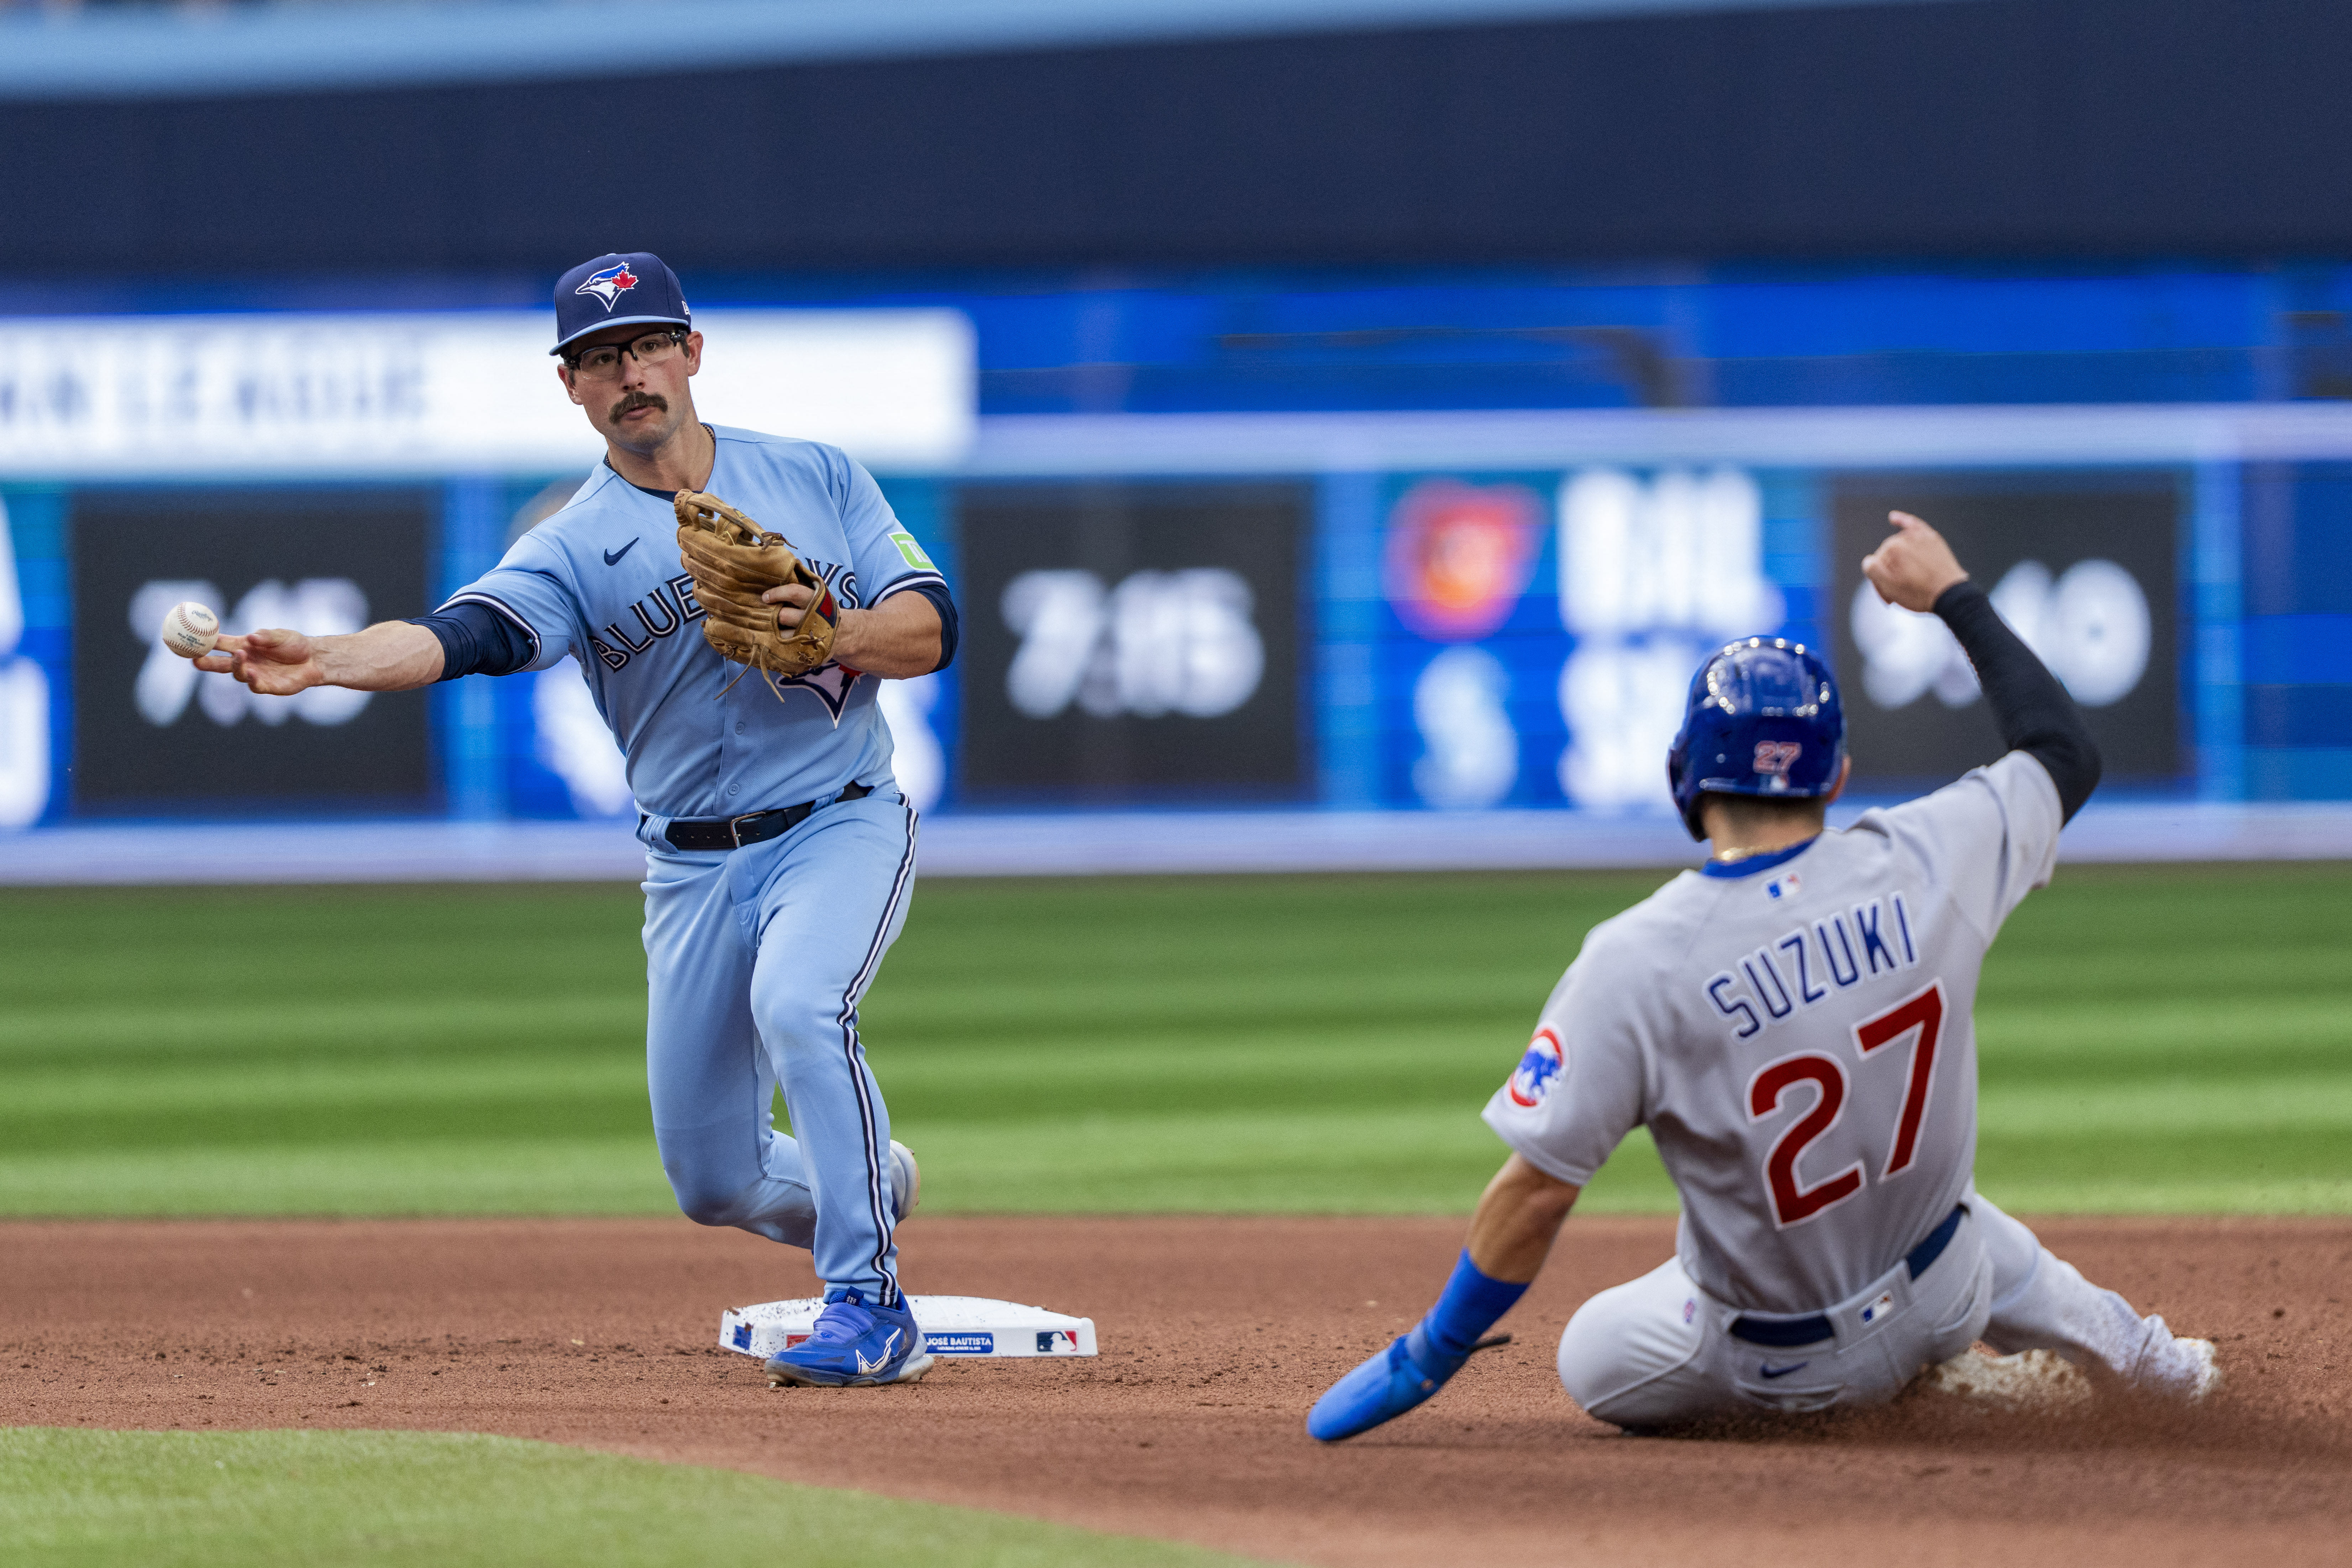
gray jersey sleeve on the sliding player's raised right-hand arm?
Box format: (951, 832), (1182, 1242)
(1886, 752), (2065, 940)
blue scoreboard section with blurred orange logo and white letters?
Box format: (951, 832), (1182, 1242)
(1374, 466), (1809, 811)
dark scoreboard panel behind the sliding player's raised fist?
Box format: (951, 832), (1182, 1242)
(1830, 470), (2194, 792)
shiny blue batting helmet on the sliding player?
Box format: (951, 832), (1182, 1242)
(1665, 637), (1846, 839)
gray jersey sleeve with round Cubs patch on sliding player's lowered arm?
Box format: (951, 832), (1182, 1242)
(1484, 931), (1649, 1187)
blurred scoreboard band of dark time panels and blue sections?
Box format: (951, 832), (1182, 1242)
(0, 463), (2216, 823)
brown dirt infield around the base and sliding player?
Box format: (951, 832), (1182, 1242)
(0, 1218), (2352, 1568)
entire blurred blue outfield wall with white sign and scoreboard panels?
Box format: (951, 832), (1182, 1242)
(0, 273), (2352, 882)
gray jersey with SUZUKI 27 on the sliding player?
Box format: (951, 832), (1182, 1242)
(1486, 752), (2060, 1312)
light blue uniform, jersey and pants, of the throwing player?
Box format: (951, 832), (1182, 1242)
(449, 428), (943, 1305)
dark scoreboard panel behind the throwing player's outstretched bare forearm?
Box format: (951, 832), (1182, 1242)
(70, 491), (437, 813)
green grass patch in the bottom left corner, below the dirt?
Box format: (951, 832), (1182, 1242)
(0, 1427), (1246, 1568)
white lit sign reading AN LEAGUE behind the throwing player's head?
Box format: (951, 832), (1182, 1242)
(0, 310), (976, 479)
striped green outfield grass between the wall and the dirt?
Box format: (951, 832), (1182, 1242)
(0, 865), (2352, 1215)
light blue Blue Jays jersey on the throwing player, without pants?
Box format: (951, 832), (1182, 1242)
(449, 425), (943, 834)
